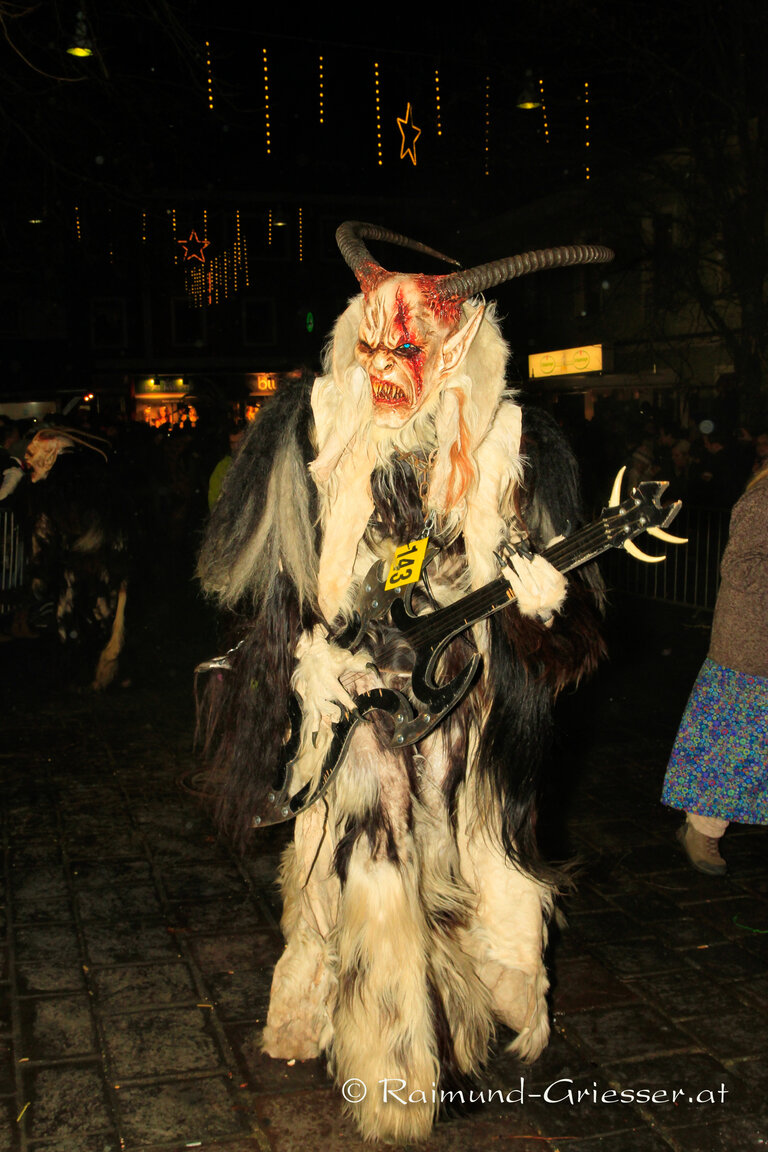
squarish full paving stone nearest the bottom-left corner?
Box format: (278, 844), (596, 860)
(23, 1064), (113, 1152)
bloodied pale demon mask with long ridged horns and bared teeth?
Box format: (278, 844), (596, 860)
(336, 220), (614, 429)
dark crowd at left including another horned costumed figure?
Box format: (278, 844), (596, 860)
(0, 417), (238, 689)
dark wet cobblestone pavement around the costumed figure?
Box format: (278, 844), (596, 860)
(0, 602), (768, 1152)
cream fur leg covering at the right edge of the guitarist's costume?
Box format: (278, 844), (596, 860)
(458, 799), (554, 1061)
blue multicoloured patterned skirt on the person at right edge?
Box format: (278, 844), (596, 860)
(661, 660), (768, 824)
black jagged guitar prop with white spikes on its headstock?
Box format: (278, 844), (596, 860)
(192, 469), (687, 827)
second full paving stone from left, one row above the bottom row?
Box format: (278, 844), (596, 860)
(102, 1008), (225, 1083)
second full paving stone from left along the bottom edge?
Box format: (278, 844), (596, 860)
(117, 1076), (252, 1150)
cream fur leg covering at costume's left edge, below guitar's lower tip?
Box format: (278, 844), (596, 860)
(261, 804), (339, 1060)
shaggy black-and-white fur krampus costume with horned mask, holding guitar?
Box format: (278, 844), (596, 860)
(199, 223), (611, 1142)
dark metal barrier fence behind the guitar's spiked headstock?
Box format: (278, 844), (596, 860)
(600, 507), (731, 608)
